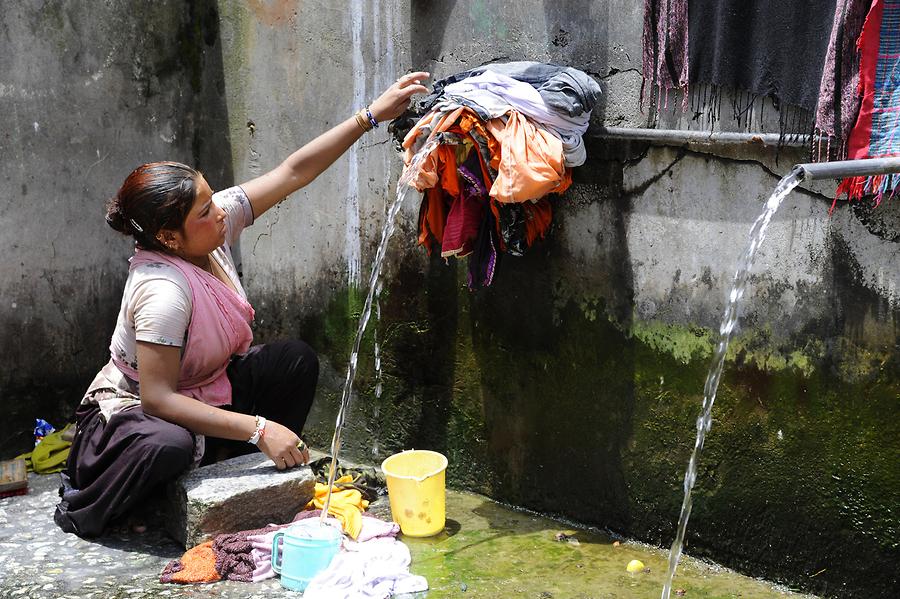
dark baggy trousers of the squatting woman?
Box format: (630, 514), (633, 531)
(54, 341), (319, 537)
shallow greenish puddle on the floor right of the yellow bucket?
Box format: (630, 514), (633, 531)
(398, 491), (815, 599)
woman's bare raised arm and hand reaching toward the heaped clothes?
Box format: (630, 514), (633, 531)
(241, 71), (428, 217)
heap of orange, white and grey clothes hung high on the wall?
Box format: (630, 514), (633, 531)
(402, 61), (600, 289)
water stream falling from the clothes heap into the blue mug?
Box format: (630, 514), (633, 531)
(320, 134), (438, 525)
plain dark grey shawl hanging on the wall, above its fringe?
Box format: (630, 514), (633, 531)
(688, 0), (835, 112)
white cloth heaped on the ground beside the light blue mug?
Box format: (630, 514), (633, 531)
(303, 537), (428, 599)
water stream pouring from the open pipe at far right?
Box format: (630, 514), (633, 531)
(662, 170), (803, 599)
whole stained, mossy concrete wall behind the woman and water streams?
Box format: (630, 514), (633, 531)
(0, 0), (900, 598)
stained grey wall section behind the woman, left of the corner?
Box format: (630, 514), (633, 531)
(0, 0), (231, 454)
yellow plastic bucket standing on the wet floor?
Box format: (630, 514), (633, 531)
(381, 449), (447, 537)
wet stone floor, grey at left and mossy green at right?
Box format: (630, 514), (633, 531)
(0, 475), (814, 599)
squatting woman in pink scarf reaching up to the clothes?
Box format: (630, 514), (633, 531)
(54, 72), (428, 537)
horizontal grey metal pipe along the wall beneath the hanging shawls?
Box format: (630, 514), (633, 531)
(588, 127), (813, 147)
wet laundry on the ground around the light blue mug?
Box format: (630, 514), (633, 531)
(160, 458), (428, 599)
